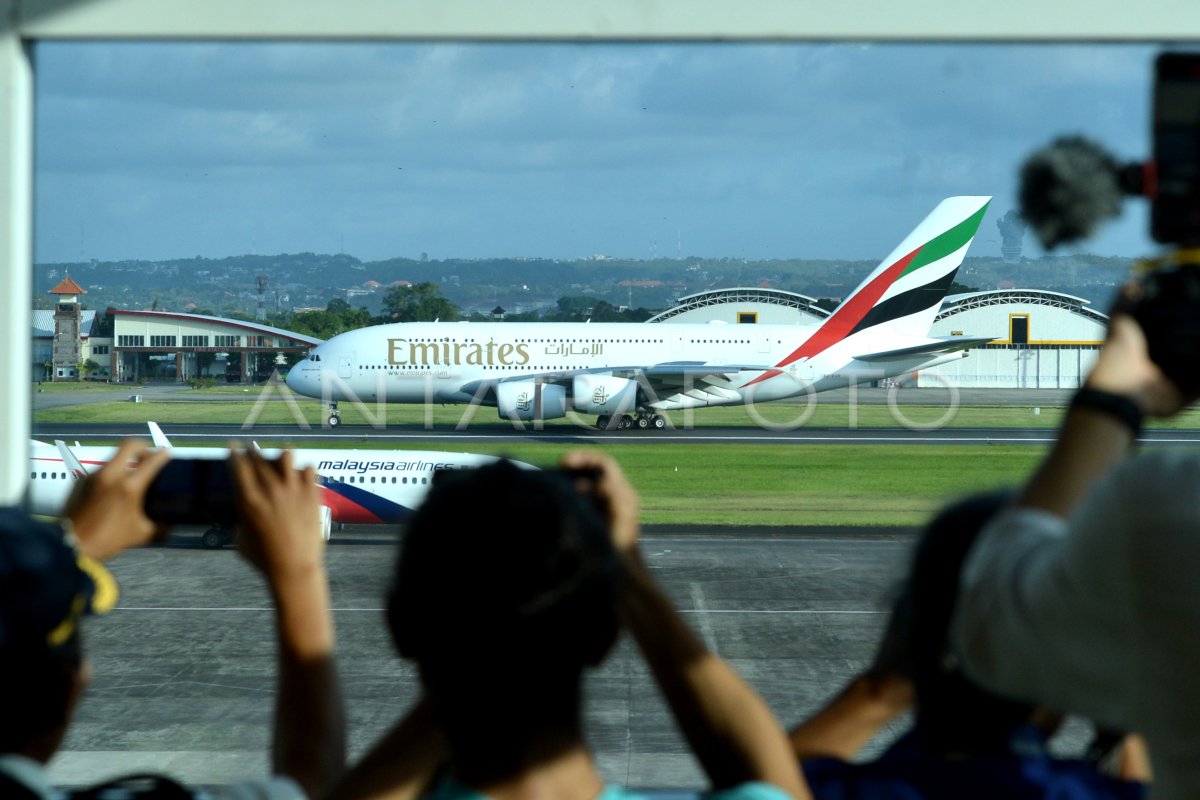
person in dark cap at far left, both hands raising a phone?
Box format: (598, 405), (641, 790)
(0, 440), (344, 800)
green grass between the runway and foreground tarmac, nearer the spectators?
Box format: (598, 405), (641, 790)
(453, 443), (1044, 525)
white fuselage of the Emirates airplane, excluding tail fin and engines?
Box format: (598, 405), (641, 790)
(288, 323), (961, 411)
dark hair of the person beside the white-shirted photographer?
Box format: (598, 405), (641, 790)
(896, 492), (1033, 754)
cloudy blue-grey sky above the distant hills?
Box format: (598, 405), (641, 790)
(35, 43), (1154, 261)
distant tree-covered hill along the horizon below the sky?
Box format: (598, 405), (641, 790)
(32, 253), (1132, 315)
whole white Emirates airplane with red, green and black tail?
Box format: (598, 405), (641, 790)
(287, 197), (991, 428)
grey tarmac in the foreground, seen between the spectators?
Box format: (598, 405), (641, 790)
(52, 527), (911, 787)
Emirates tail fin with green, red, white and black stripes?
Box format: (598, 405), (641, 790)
(781, 197), (991, 365)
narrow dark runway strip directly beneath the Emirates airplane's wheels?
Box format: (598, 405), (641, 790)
(32, 423), (1200, 447)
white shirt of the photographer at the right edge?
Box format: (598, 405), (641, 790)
(950, 452), (1200, 800)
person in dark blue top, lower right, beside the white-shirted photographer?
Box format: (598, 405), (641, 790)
(792, 493), (1144, 800)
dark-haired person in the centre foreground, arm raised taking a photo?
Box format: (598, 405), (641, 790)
(335, 452), (808, 800)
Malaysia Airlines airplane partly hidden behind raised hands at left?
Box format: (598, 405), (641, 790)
(29, 422), (533, 547)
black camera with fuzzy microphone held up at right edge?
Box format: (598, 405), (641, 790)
(1020, 53), (1200, 393)
